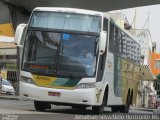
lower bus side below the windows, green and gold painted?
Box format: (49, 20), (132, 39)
(107, 53), (139, 105)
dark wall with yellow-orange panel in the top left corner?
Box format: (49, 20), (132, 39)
(0, 1), (30, 32)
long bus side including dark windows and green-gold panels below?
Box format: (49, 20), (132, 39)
(107, 21), (140, 105)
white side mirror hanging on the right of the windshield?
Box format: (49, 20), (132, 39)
(99, 31), (107, 54)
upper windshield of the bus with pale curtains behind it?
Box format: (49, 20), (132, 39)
(29, 11), (101, 33)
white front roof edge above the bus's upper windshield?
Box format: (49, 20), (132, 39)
(33, 7), (103, 16)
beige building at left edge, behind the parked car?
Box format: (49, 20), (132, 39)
(0, 36), (17, 91)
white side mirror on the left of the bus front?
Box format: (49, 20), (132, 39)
(14, 24), (26, 45)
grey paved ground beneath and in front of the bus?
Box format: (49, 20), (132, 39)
(0, 99), (160, 120)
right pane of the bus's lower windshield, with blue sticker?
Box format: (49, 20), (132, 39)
(58, 34), (96, 76)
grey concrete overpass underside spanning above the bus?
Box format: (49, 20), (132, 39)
(5, 0), (160, 11)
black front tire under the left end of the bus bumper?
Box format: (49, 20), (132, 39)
(34, 101), (51, 111)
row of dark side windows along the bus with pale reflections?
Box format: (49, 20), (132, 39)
(109, 23), (140, 64)
